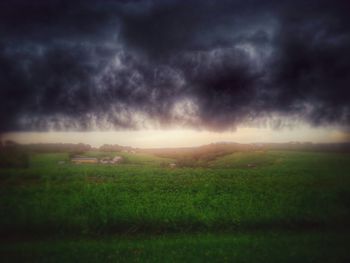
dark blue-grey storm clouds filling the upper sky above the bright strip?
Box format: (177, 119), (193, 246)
(0, 0), (350, 131)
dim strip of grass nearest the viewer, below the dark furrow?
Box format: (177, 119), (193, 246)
(0, 232), (350, 263)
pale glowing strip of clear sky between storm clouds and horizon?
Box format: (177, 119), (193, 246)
(2, 126), (350, 148)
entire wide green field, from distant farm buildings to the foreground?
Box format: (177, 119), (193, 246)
(0, 151), (350, 262)
